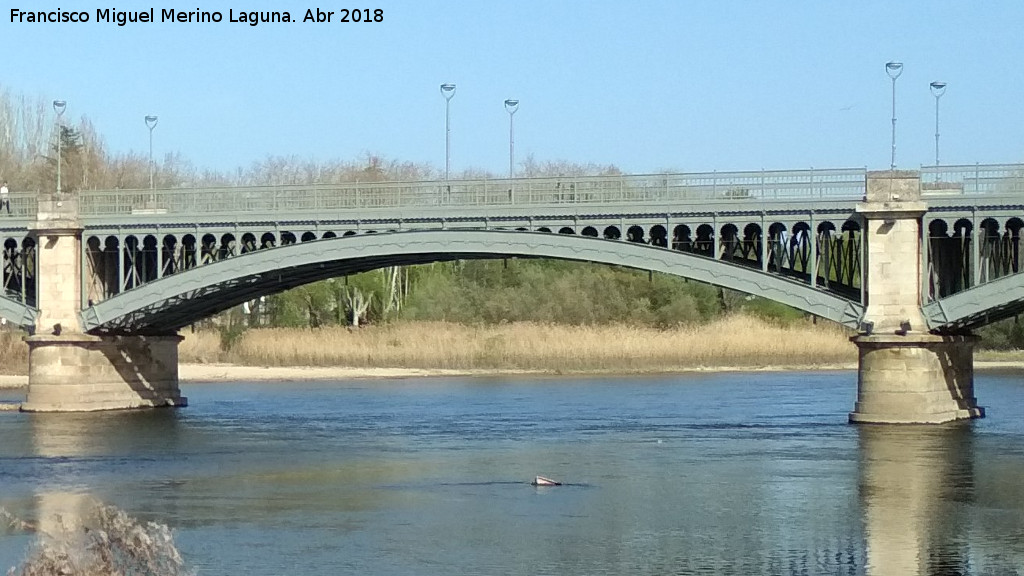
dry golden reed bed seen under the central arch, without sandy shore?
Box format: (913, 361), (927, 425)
(180, 316), (856, 372)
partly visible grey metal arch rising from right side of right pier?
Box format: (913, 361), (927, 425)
(922, 274), (1024, 333)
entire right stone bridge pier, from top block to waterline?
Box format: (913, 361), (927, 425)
(850, 171), (985, 423)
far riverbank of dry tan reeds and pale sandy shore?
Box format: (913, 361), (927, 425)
(0, 316), (1024, 388)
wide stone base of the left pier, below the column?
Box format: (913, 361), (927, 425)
(22, 334), (187, 412)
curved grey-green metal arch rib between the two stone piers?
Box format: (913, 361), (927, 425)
(82, 230), (863, 334)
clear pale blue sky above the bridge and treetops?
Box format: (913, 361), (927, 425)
(0, 0), (1024, 175)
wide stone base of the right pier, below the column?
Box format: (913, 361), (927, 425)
(850, 334), (985, 424)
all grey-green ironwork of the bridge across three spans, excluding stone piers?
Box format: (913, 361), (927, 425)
(6, 165), (1024, 333)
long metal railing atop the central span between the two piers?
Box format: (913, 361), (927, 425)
(72, 168), (865, 216)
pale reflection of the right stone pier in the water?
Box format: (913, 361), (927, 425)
(858, 424), (975, 576)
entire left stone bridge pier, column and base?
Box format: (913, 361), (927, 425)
(22, 196), (187, 412)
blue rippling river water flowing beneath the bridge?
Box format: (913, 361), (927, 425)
(0, 372), (1024, 576)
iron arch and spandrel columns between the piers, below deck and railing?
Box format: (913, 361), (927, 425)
(84, 222), (860, 333)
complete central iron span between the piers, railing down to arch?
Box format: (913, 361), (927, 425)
(59, 169), (864, 333)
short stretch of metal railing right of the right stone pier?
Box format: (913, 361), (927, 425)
(921, 164), (1024, 197)
